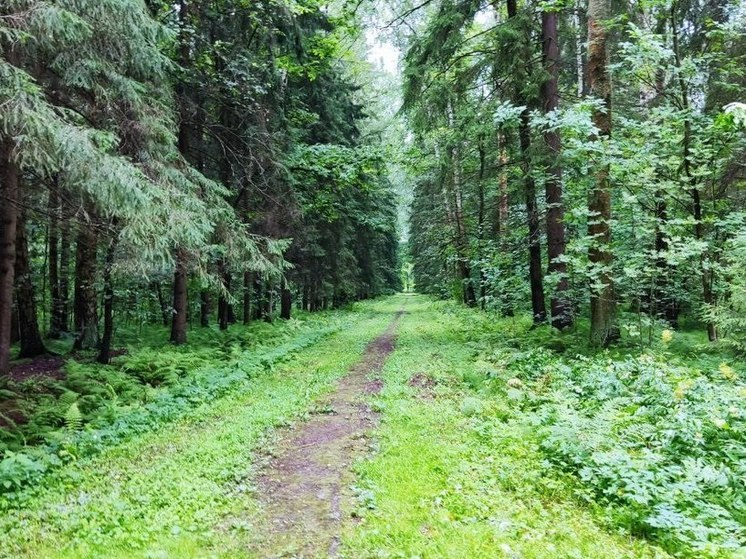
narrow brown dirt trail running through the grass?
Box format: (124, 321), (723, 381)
(253, 311), (404, 559)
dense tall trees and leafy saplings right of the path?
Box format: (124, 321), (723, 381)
(404, 0), (746, 349)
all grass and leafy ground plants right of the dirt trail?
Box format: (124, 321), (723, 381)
(346, 299), (746, 559)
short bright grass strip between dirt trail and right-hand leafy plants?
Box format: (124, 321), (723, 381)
(344, 297), (740, 559)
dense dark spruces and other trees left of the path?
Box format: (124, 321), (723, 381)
(0, 0), (399, 373)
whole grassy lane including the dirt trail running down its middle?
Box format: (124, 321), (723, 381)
(0, 294), (740, 559)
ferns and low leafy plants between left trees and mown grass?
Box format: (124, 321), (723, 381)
(0, 313), (344, 496)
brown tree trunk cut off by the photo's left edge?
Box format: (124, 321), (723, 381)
(0, 136), (20, 375)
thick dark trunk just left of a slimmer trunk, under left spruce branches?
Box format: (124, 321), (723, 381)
(73, 218), (99, 350)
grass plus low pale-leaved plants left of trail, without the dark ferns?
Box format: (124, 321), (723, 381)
(0, 301), (399, 559)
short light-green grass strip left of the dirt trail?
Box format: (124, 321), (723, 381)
(0, 299), (398, 559)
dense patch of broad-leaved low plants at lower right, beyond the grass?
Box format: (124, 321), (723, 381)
(486, 348), (746, 557)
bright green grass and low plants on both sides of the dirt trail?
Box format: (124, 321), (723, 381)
(0, 295), (746, 559)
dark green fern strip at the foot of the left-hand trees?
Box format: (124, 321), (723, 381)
(0, 312), (354, 456)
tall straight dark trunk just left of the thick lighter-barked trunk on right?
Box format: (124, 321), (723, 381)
(541, 11), (572, 329)
